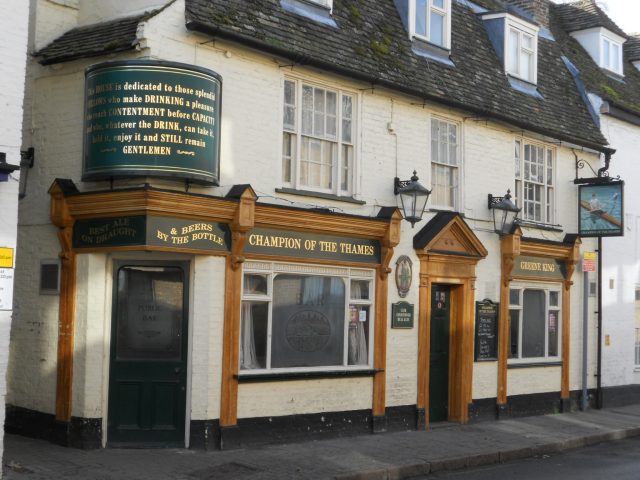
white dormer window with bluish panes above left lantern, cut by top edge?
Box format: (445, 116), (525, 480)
(409, 0), (451, 49)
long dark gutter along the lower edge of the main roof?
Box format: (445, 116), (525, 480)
(185, 20), (615, 154)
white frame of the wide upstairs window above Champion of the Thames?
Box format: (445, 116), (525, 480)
(280, 76), (361, 196)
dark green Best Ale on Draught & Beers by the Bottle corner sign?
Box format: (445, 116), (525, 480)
(73, 215), (231, 251)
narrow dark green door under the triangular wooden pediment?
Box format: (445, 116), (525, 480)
(429, 285), (451, 422)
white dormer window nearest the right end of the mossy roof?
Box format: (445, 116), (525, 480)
(505, 22), (538, 84)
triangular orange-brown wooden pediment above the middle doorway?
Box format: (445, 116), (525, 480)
(413, 212), (488, 259)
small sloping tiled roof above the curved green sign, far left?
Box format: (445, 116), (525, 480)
(35, 10), (158, 65)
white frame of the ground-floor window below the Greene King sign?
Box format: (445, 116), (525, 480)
(508, 282), (564, 365)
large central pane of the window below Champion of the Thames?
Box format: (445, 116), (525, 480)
(271, 274), (345, 368)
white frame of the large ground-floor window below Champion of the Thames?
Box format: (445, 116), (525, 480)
(239, 262), (376, 376)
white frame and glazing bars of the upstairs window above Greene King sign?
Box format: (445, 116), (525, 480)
(514, 138), (558, 225)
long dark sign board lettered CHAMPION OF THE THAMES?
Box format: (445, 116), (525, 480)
(244, 228), (380, 263)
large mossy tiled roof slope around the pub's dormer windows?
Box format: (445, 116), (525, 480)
(185, 0), (607, 149)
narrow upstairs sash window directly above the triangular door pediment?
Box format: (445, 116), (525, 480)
(431, 118), (461, 210)
